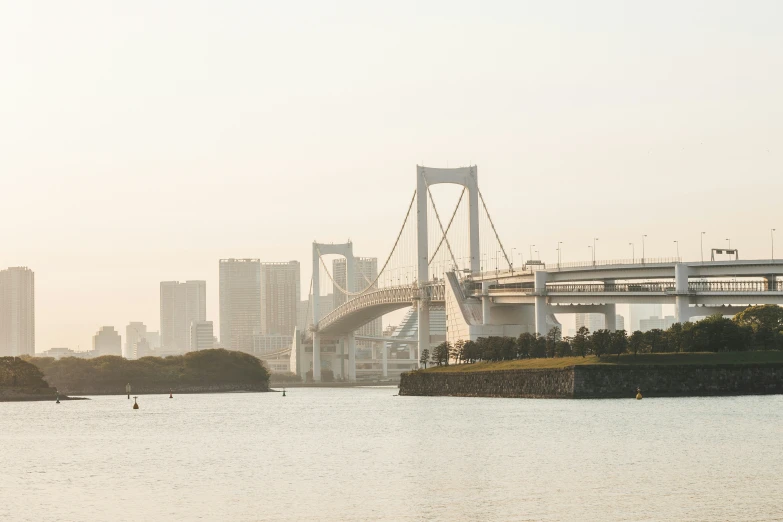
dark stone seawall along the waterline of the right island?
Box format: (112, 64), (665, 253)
(400, 364), (783, 399)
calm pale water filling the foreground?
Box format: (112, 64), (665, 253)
(0, 388), (783, 522)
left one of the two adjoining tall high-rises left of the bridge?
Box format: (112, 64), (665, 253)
(220, 259), (261, 353)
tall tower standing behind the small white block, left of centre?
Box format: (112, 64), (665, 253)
(160, 281), (207, 353)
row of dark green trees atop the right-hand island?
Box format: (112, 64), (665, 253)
(422, 305), (783, 366)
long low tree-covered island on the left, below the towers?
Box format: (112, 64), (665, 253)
(27, 349), (269, 393)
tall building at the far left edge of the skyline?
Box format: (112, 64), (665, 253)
(0, 267), (35, 357)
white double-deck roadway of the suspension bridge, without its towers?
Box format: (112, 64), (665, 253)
(318, 260), (783, 335)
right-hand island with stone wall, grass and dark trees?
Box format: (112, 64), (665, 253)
(400, 305), (783, 397)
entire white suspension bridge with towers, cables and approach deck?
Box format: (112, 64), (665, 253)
(291, 166), (783, 382)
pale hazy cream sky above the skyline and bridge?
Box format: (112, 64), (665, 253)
(0, 0), (783, 351)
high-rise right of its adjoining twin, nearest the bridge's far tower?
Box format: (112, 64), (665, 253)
(261, 261), (301, 335)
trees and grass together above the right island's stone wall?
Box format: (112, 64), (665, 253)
(430, 305), (783, 371)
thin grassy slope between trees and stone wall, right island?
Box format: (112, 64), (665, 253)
(419, 351), (783, 372)
